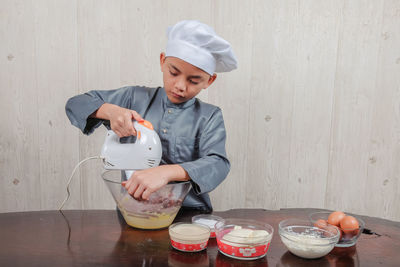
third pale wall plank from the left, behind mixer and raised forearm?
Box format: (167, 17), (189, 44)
(78, 0), (121, 209)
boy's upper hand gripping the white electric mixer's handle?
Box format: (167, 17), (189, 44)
(93, 103), (143, 137)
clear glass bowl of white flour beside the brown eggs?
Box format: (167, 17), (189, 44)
(279, 219), (340, 259)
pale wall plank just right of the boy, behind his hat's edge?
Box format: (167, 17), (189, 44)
(207, 1), (253, 209)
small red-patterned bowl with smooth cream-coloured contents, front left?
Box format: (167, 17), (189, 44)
(168, 222), (211, 252)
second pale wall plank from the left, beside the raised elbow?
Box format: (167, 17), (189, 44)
(33, 0), (81, 209)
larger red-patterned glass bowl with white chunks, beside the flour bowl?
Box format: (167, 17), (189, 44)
(215, 219), (274, 260)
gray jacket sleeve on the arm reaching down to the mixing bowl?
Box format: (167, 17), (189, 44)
(180, 109), (230, 194)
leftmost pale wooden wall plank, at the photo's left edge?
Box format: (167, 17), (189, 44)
(0, 1), (41, 211)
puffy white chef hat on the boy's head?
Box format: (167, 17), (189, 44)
(165, 20), (237, 75)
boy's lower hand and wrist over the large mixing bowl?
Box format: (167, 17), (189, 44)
(122, 164), (189, 200)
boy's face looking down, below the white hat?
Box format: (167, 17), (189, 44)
(160, 53), (217, 104)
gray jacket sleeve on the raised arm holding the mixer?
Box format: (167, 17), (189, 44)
(65, 87), (133, 135)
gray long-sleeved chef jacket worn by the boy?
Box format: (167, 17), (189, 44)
(65, 86), (230, 212)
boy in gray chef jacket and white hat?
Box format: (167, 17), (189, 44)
(66, 20), (237, 212)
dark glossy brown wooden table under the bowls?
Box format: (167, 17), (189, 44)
(0, 209), (400, 267)
